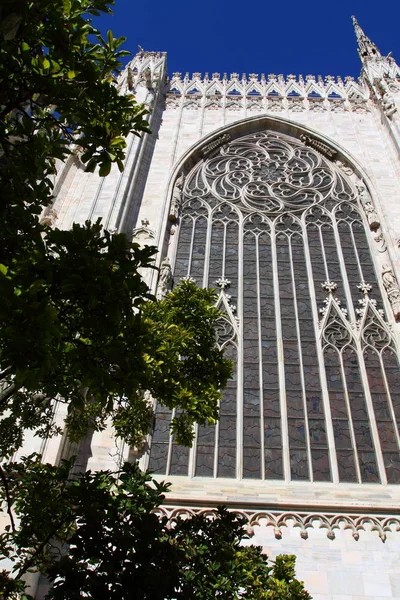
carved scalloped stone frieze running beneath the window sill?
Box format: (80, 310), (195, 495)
(154, 506), (400, 542)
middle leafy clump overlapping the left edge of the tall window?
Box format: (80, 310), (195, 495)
(0, 218), (231, 455)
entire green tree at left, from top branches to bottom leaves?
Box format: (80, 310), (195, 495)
(0, 0), (308, 600)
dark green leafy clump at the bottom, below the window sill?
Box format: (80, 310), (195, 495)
(0, 456), (310, 600)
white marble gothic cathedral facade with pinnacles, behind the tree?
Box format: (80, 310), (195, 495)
(37, 17), (400, 600)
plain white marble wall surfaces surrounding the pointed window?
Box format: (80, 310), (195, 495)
(42, 72), (400, 600)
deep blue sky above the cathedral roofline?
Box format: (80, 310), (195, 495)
(95, 0), (400, 77)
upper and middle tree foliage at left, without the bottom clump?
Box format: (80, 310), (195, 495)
(0, 0), (230, 456)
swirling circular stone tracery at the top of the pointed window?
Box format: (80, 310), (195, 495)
(185, 132), (355, 214)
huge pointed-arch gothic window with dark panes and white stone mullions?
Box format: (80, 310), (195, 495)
(150, 132), (400, 483)
